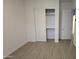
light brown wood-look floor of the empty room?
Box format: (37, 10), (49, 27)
(6, 40), (76, 59)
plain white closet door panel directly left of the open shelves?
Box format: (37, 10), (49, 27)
(34, 8), (46, 41)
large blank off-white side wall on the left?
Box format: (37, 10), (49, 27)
(3, 0), (27, 57)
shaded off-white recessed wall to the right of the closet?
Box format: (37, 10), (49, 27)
(60, 2), (72, 39)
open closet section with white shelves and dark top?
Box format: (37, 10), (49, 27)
(45, 9), (55, 42)
